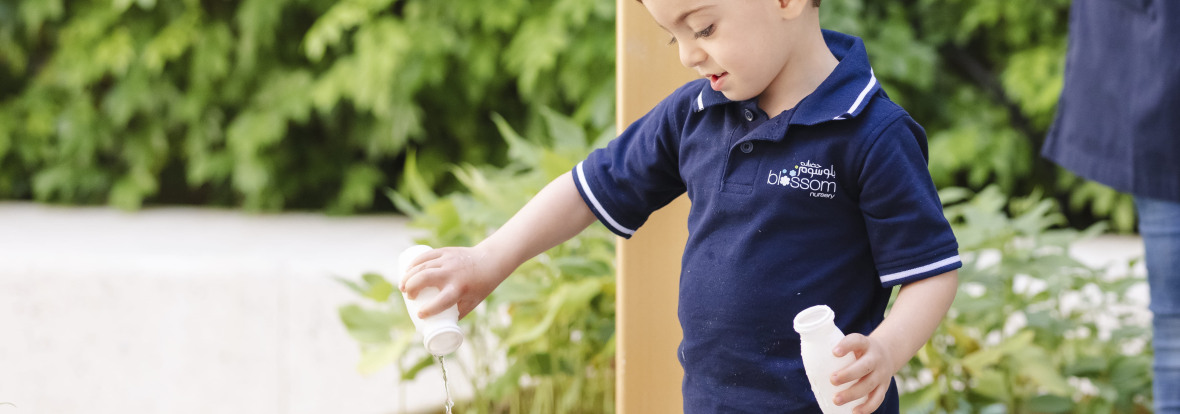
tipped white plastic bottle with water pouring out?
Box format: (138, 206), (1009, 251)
(398, 244), (463, 356)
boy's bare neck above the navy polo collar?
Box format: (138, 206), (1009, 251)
(758, 22), (840, 118)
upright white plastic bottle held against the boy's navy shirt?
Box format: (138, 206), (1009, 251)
(794, 304), (866, 414)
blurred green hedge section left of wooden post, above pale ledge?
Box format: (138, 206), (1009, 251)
(0, 0), (615, 212)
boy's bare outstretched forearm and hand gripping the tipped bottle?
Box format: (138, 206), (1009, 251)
(398, 172), (596, 318)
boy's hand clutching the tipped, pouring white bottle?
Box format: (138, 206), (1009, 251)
(398, 248), (509, 318)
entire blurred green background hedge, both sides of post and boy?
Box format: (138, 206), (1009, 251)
(0, 0), (1134, 232)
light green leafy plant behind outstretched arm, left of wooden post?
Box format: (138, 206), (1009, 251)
(340, 110), (615, 413)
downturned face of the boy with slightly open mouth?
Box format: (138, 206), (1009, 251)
(643, 0), (811, 100)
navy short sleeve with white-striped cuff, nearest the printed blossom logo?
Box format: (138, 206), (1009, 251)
(859, 114), (963, 287)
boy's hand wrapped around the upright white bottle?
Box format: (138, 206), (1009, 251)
(831, 334), (897, 414)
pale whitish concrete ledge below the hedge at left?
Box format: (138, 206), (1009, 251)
(0, 203), (463, 414)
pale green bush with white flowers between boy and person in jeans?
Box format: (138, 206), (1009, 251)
(899, 186), (1152, 413)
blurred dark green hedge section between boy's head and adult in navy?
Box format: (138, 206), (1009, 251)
(821, 0), (1134, 231)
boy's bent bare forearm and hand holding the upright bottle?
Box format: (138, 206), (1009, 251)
(832, 270), (958, 414)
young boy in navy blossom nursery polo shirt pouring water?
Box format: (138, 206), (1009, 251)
(400, 0), (962, 414)
